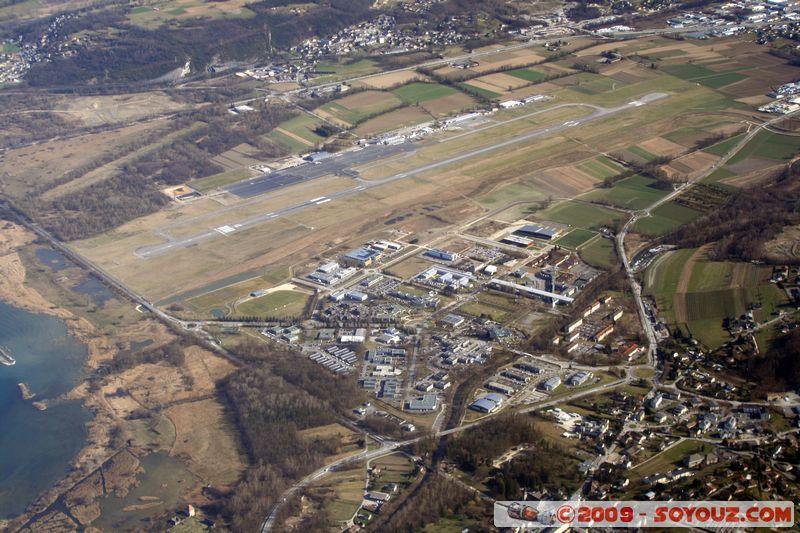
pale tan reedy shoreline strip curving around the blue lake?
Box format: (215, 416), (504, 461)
(0, 222), (116, 530)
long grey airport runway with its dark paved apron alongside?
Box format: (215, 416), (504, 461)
(135, 93), (668, 259)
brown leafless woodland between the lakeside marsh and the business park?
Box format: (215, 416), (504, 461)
(220, 341), (361, 531)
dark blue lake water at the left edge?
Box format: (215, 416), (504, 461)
(0, 301), (91, 518)
